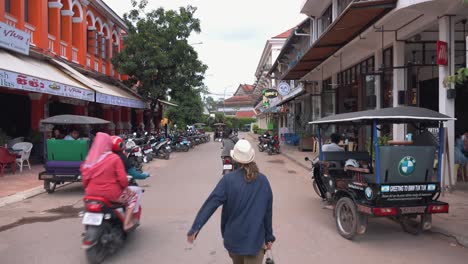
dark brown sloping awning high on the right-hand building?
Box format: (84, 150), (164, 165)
(281, 0), (397, 80)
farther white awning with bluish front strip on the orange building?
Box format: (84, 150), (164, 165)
(53, 60), (148, 108)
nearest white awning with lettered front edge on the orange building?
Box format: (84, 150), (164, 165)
(0, 50), (95, 102)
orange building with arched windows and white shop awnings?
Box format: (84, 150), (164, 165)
(0, 0), (147, 137)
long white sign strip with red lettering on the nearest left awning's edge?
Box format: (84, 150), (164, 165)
(0, 70), (94, 102)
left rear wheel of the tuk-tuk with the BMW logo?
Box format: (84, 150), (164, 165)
(335, 197), (367, 240)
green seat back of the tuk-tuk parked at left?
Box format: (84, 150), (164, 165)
(47, 139), (89, 161)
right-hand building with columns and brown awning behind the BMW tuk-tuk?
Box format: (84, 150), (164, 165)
(271, 0), (468, 186)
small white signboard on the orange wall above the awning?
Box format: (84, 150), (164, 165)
(0, 22), (31, 55)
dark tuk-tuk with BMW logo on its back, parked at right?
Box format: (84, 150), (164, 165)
(306, 107), (454, 239)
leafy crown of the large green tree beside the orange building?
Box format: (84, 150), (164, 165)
(112, 0), (207, 118)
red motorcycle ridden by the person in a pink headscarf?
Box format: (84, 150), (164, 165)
(81, 176), (142, 263)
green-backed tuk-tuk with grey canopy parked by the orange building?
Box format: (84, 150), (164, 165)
(39, 115), (109, 193)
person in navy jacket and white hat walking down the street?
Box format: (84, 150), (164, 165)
(187, 140), (275, 264)
